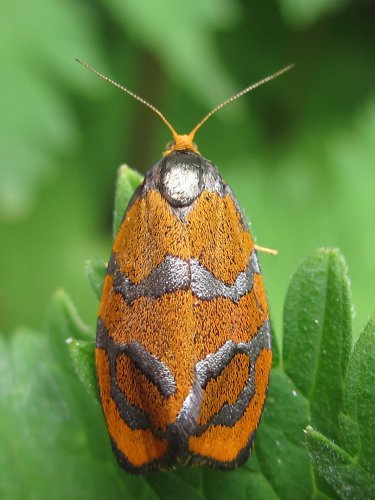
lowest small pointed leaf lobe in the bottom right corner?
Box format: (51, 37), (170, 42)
(306, 427), (375, 500)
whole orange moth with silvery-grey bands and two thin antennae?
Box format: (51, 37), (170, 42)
(77, 63), (290, 474)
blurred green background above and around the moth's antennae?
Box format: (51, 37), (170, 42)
(0, 0), (375, 344)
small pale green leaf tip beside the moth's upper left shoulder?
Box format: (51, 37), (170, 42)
(113, 165), (143, 238)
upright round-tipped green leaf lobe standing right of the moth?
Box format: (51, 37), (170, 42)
(283, 249), (352, 438)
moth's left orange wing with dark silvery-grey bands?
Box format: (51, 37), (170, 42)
(96, 190), (194, 472)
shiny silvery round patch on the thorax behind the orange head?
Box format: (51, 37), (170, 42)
(159, 152), (203, 207)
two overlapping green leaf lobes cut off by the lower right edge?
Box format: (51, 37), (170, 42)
(307, 315), (375, 499)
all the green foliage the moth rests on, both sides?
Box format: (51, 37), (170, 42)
(0, 168), (375, 500)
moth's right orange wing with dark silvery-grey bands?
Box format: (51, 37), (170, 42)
(188, 192), (271, 469)
